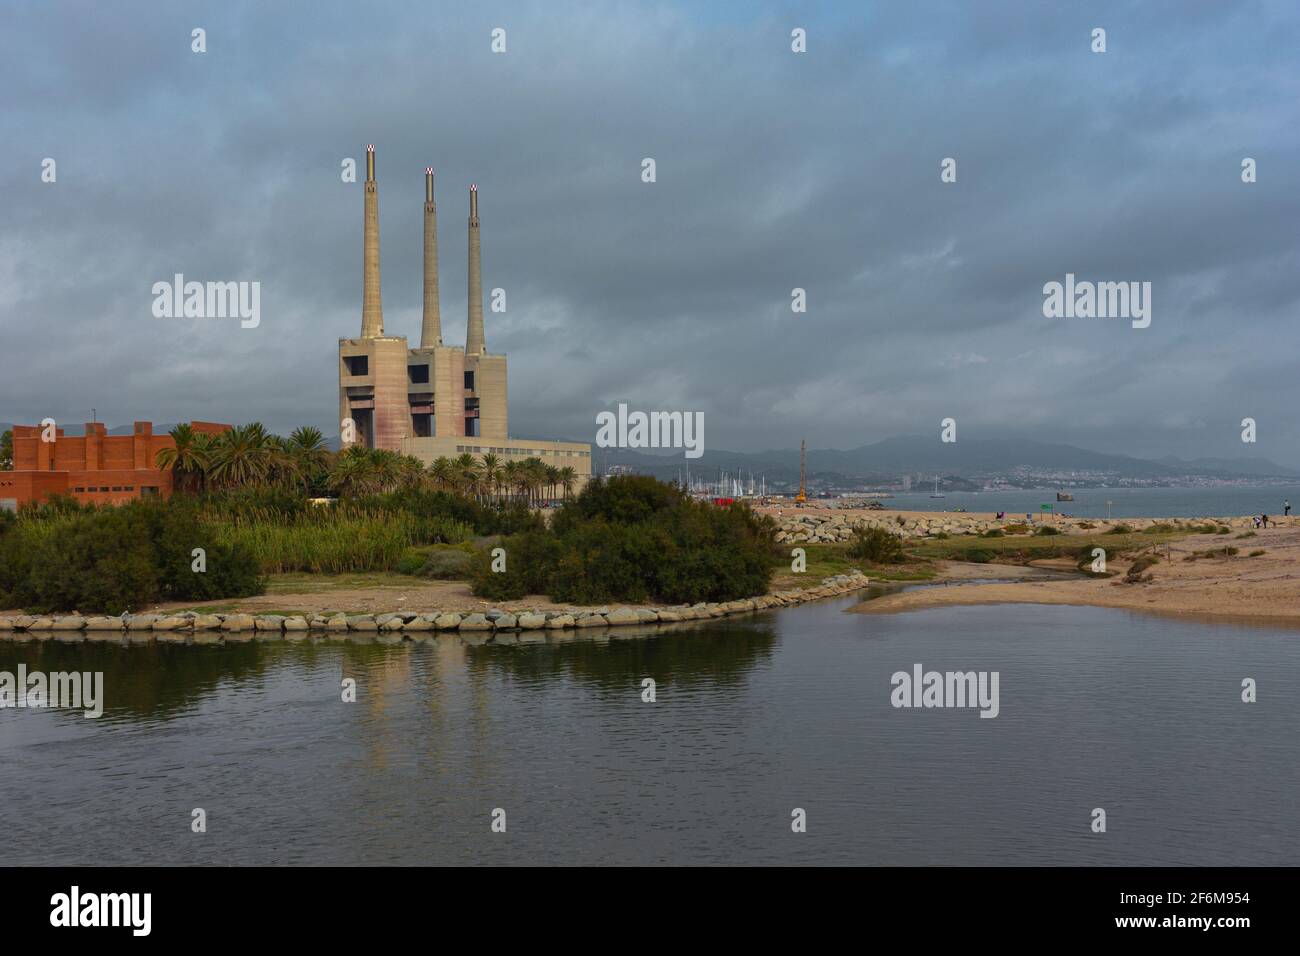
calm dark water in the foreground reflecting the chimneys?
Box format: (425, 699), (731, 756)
(0, 600), (1300, 865)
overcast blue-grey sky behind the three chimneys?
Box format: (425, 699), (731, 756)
(0, 0), (1300, 464)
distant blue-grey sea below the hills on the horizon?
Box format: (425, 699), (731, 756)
(883, 485), (1300, 518)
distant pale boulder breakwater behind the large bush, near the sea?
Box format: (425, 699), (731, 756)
(772, 511), (1255, 544)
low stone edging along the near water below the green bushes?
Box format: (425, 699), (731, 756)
(0, 571), (868, 644)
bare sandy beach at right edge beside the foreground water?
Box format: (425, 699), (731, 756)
(853, 525), (1300, 624)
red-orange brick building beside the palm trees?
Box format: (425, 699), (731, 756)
(0, 421), (230, 509)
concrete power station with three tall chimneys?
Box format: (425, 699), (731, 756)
(338, 146), (592, 486)
